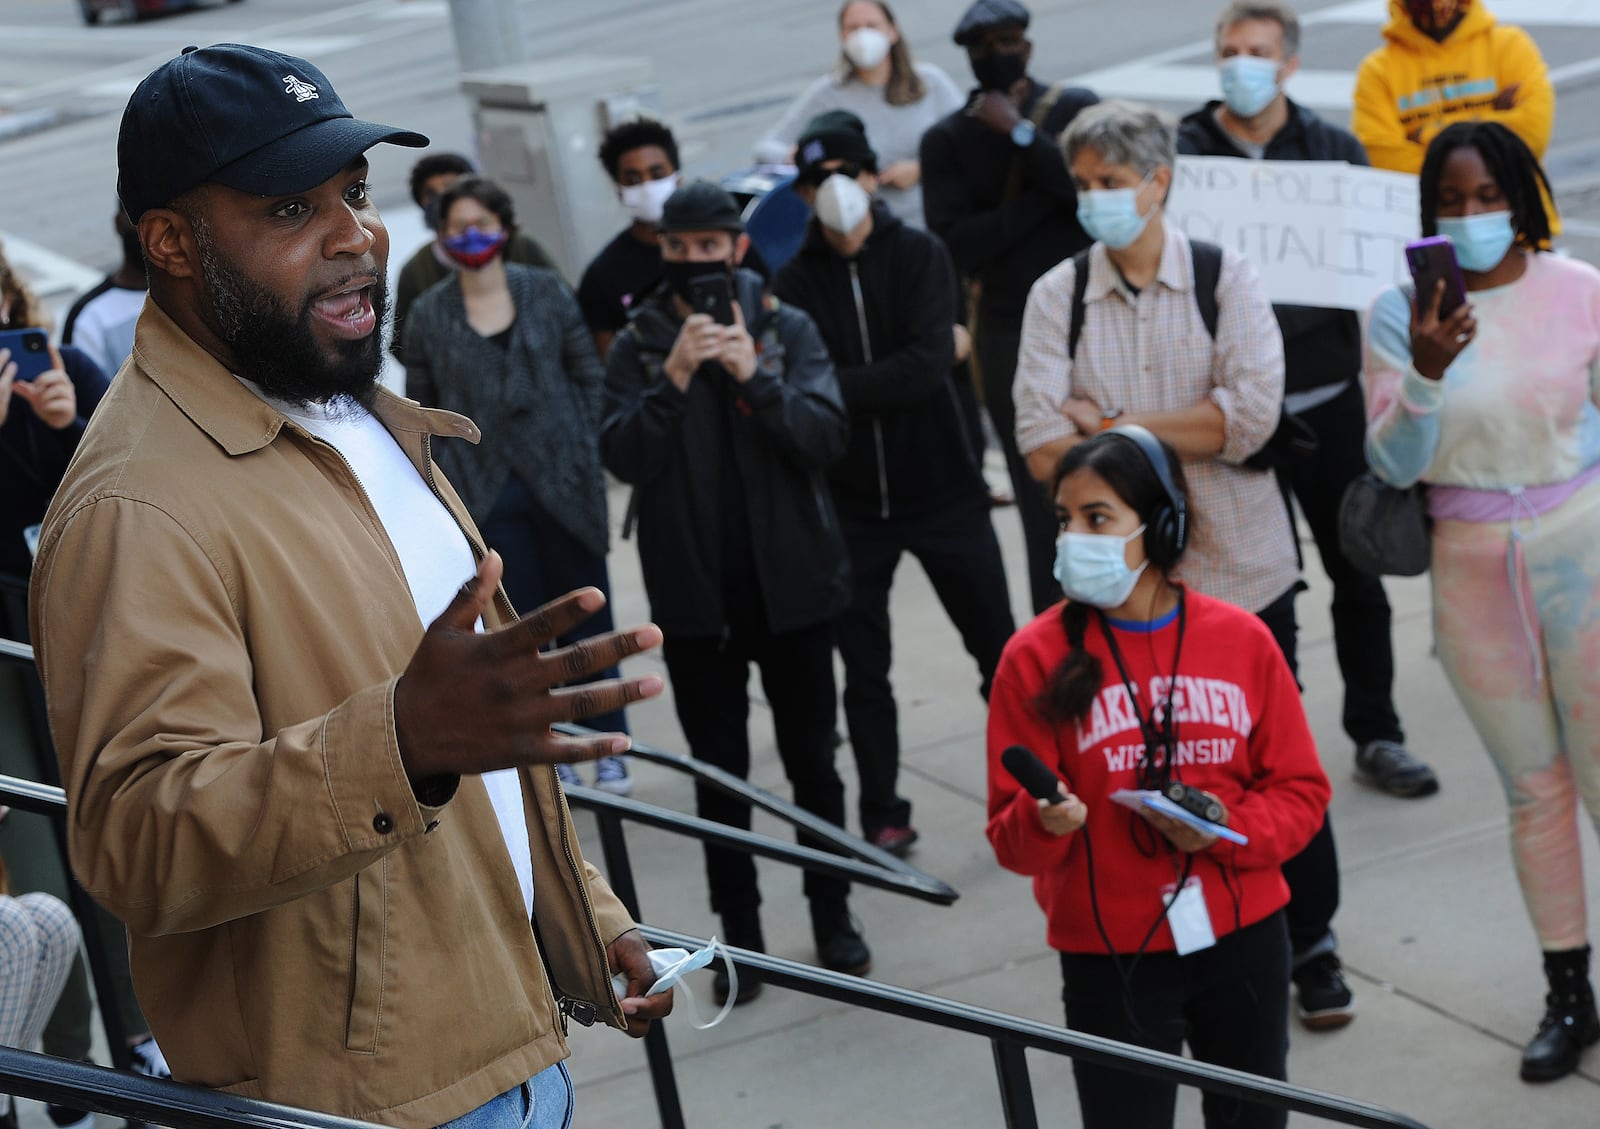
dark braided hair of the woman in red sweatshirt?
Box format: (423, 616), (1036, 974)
(1034, 435), (1189, 724)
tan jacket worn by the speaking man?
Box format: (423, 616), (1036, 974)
(32, 302), (632, 1129)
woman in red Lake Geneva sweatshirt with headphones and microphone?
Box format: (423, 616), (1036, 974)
(987, 427), (1331, 1129)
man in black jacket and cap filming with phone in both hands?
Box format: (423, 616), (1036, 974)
(600, 181), (872, 1003)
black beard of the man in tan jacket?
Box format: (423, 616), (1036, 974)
(195, 232), (389, 409)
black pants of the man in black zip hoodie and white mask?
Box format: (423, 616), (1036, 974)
(838, 491), (1014, 836)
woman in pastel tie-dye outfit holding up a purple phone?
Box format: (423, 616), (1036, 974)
(1365, 122), (1600, 1083)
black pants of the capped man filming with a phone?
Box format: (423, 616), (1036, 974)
(662, 624), (850, 915)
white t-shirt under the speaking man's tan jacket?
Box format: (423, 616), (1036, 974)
(238, 377), (533, 918)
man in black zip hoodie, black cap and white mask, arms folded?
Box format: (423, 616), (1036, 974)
(774, 110), (1013, 856)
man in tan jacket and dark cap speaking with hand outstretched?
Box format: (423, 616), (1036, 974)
(30, 45), (672, 1129)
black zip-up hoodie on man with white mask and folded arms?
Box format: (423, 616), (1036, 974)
(773, 201), (987, 520)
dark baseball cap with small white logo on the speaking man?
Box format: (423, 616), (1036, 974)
(117, 43), (427, 222)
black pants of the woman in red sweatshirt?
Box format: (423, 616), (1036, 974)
(1061, 894), (1290, 1129)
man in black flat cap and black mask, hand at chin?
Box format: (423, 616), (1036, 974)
(922, 0), (1099, 611)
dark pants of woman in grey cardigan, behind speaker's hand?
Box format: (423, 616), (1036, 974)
(478, 475), (627, 732)
